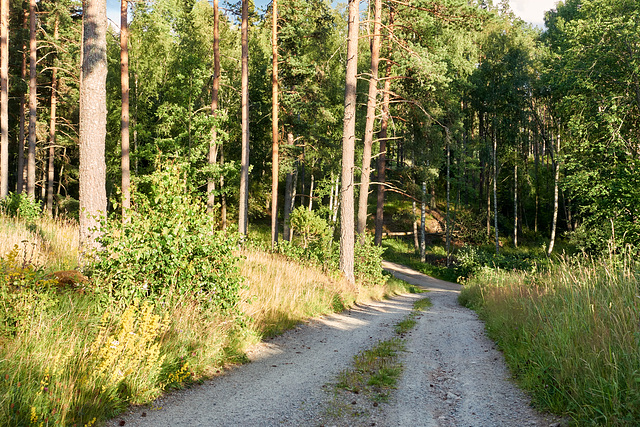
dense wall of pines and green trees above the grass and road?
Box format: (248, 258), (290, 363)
(0, 0), (640, 275)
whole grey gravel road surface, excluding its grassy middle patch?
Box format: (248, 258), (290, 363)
(106, 262), (561, 427)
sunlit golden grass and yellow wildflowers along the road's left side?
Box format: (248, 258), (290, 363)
(0, 216), (417, 426)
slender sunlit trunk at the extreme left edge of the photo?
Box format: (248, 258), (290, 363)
(0, 0), (9, 199)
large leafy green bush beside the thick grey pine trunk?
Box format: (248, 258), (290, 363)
(92, 165), (240, 310)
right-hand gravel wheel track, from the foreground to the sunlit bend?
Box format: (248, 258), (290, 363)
(377, 262), (559, 427)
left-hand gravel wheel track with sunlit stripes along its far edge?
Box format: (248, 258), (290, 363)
(106, 295), (421, 427)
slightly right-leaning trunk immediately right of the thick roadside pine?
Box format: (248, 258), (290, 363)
(356, 0), (382, 244)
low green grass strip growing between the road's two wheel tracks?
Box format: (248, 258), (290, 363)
(326, 292), (431, 424)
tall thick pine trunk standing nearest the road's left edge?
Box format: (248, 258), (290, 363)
(340, 0), (360, 283)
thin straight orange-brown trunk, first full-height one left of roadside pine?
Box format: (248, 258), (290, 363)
(271, 0), (280, 250)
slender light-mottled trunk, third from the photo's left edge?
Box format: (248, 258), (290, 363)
(27, 0), (38, 198)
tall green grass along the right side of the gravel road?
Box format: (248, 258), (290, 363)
(460, 254), (640, 426)
